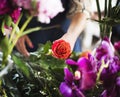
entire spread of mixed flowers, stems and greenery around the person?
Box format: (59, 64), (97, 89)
(0, 0), (120, 97)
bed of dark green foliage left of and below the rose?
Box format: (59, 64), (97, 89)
(0, 42), (66, 97)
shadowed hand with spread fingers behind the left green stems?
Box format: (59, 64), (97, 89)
(16, 35), (33, 57)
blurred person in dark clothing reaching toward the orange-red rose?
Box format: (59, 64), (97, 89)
(16, 0), (90, 56)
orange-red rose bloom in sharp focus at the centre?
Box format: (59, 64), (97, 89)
(52, 40), (71, 59)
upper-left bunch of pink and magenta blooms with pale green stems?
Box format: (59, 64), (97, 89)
(0, 0), (64, 68)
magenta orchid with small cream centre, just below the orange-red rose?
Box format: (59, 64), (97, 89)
(60, 56), (96, 97)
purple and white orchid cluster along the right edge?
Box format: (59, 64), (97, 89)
(95, 38), (120, 97)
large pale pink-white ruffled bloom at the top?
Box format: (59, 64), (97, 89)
(38, 0), (64, 23)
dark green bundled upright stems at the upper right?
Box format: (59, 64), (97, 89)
(95, 0), (120, 38)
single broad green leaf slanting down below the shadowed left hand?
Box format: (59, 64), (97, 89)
(12, 55), (32, 78)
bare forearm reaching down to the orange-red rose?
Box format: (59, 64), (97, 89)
(60, 5), (90, 51)
